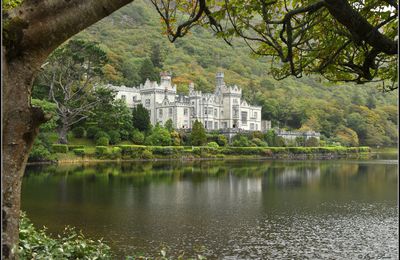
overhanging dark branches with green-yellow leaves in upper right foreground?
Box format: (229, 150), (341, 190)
(151, 0), (398, 90)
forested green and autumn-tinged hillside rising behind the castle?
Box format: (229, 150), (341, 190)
(55, 1), (398, 146)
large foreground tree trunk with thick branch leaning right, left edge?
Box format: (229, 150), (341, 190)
(1, 0), (132, 259)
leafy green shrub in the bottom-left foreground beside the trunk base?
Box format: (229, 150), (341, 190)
(18, 213), (111, 259)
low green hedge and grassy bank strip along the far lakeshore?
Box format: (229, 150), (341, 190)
(38, 144), (371, 163)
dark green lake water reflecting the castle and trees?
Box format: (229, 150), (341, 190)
(22, 160), (399, 259)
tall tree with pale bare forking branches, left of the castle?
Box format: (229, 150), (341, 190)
(34, 40), (107, 143)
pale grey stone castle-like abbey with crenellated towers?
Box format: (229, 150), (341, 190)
(108, 72), (271, 131)
